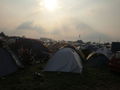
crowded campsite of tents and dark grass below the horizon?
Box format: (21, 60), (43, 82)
(0, 33), (120, 90)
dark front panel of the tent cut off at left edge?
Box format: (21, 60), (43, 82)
(0, 48), (18, 76)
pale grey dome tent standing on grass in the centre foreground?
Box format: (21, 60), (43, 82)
(44, 48), (83, 73)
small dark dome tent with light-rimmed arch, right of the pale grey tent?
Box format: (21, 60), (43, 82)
(86, 52), (109, 68)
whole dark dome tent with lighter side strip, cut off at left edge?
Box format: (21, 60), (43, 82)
(0, 40), (24, 77)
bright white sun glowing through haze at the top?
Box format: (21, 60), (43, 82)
(43, 0), (58, 11)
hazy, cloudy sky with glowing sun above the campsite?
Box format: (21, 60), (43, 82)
(0, 0), (120, 42)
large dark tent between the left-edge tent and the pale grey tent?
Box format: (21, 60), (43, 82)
(9, 38), (49, 65)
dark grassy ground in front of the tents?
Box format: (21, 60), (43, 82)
(0, 65), (120, 90)
